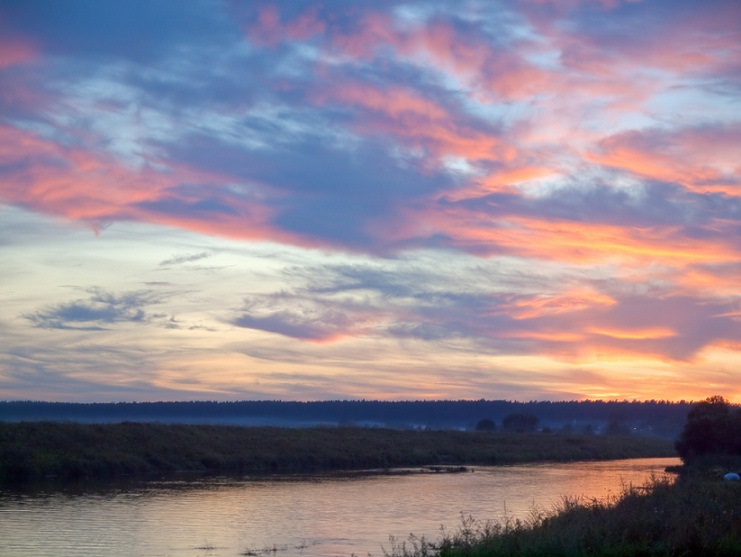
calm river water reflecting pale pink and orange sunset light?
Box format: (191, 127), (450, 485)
(0, 459), (679, 557)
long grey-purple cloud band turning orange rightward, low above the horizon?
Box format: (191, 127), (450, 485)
(225, 258), (741, 361)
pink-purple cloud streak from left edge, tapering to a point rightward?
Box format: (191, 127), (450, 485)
(0, 127), (312, 245)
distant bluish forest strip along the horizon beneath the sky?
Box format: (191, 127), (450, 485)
(0, 399), (693, 439)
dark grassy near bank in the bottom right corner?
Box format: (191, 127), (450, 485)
(387, 470), (741, 557)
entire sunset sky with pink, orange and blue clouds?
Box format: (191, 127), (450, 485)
(0, 0), (741, 402)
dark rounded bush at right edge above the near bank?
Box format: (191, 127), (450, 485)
(676, 396), (741, 464)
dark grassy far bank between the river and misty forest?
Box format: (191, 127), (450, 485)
(0, 422), (675, 482)
